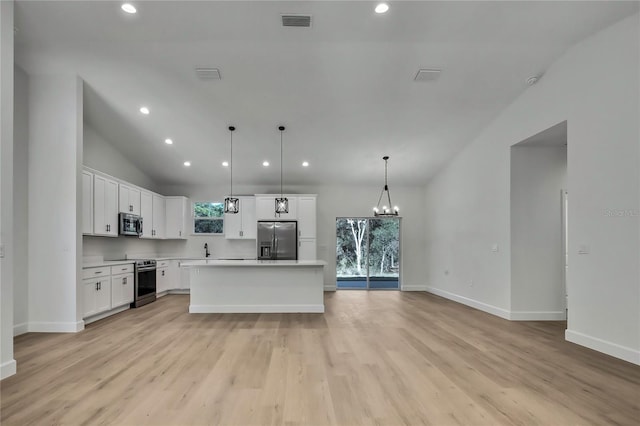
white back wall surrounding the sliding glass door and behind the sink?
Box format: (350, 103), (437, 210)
(161, 178), (426, 290)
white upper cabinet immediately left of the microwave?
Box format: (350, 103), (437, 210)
(93, 175), (118, 237)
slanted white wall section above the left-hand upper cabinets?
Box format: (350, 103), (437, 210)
(83, 122), (157, 192)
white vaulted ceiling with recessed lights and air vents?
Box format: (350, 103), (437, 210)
(15, 1), (638, 185)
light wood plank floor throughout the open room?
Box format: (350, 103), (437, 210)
(0, 291), (640, 426)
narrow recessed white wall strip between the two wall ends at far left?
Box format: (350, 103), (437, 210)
(13, 67), (29, 335)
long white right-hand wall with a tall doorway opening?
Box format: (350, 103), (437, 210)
(424, 14), (640, 364)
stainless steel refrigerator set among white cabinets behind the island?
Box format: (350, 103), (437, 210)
(257, 220), (298, 260)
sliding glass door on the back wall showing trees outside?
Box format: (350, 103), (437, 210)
(336, 217), (400, 290)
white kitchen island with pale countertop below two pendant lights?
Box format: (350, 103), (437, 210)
(180, 260), (326, 313)
